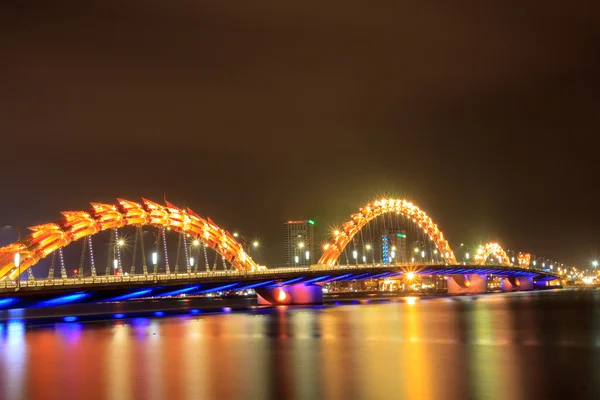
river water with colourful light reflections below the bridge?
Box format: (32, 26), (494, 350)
(0, 290), (600, 400)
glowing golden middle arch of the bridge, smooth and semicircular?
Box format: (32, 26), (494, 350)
(319, 199), (456, 266)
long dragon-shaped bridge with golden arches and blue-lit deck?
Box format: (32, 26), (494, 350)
(0, 199), (559, 309)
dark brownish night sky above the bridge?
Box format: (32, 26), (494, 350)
(0, 0), (600, 266)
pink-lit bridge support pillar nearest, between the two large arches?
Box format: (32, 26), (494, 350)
(256, 284), (323, 306)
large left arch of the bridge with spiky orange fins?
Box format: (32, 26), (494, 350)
(0, 199), (260, 280)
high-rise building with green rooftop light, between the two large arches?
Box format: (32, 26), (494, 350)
(283, 219), (315, 267)
